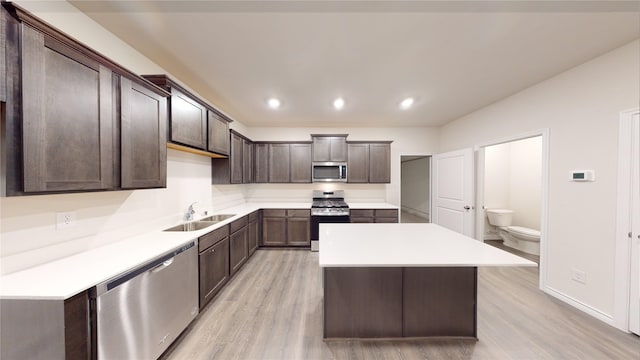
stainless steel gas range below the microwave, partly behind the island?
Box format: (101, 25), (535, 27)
(311, 190), (350, 251)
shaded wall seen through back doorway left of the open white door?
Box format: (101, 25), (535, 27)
(401, 157), (431, 219)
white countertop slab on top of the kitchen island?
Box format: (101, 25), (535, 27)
(319, 224), (537, 267)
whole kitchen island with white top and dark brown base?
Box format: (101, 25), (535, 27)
(319, 224), (537, 339)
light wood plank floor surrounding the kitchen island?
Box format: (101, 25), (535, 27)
(164, 250), (640, 360)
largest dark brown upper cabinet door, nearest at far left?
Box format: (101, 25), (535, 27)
(21, 25), (114, 192)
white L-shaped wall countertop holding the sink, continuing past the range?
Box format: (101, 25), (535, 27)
(0, 202), (397, 300)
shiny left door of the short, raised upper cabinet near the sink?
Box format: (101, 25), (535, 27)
(171, 89), (207, 150)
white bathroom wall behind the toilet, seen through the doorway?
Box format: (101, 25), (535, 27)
(484, 136), (542, 238)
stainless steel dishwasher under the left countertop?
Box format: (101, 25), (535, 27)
(95, 241), (198, 360)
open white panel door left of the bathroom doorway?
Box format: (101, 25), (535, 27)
(431, 149), (475, 237)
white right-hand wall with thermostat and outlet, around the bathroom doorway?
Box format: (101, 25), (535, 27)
(440, 40), (640, 320)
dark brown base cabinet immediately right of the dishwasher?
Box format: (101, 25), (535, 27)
(198, 226), (229, 309)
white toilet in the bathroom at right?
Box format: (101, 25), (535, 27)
(485, 209), (540, 255)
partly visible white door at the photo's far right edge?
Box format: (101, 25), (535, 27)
(629, 113), (640, 335)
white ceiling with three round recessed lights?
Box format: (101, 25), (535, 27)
(71, 0), (640, 127)
